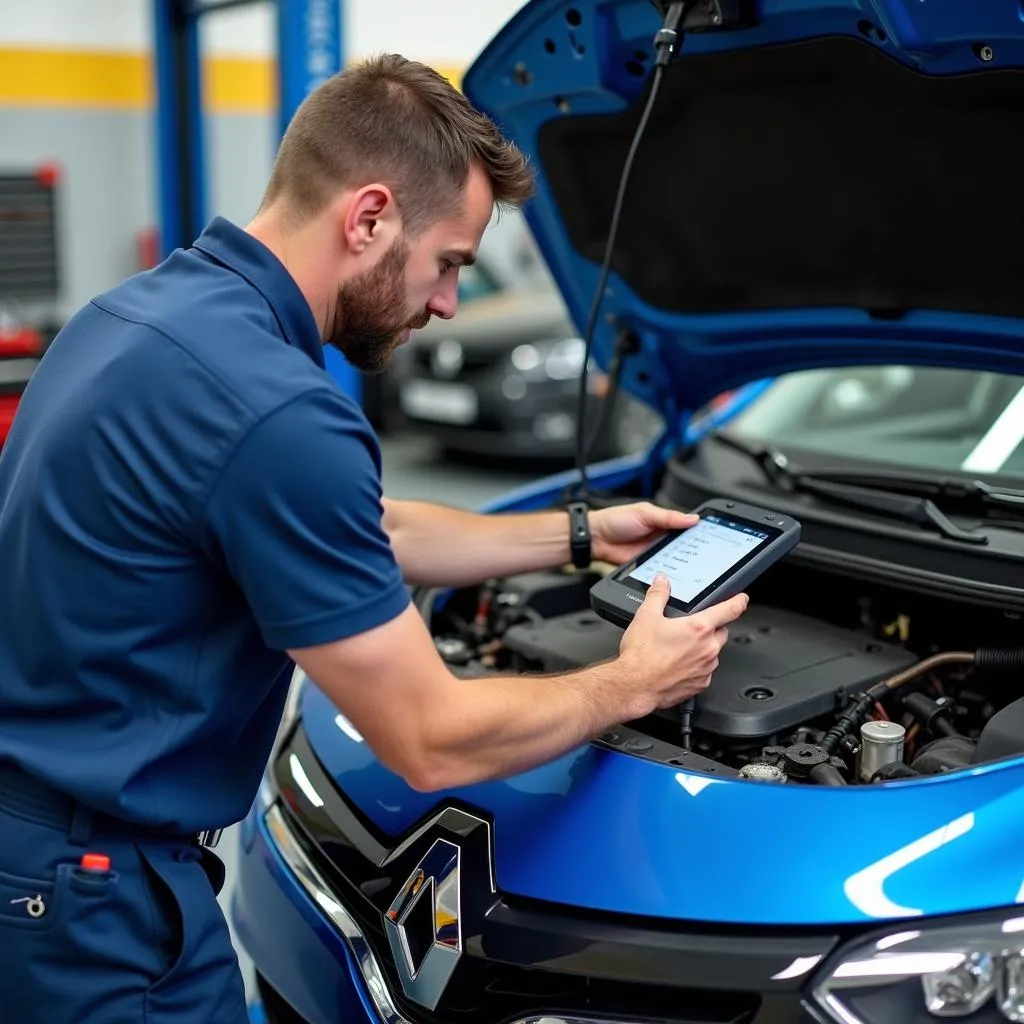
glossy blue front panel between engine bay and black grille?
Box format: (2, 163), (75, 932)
(303, 687), (1024, 926)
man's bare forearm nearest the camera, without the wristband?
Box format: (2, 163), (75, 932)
(411, 659), (626, 790)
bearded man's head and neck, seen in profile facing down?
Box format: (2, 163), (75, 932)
(250, 55), (534, 373)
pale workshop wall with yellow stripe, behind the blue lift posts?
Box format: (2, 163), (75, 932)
(0, 0), (521, 311)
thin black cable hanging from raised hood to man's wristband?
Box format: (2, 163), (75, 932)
(575, 0), (694, 505)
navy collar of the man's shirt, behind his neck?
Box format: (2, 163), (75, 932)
(194, 217), (325, 368)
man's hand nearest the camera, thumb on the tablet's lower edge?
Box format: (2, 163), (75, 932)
(617, 574), (749, 718)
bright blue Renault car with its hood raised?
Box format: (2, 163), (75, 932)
(231, 0), (1024, 1024)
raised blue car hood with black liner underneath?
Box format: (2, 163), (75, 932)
(464, 0), (1024, 422)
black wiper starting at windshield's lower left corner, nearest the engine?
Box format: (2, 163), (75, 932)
(711, 432), (988, 545)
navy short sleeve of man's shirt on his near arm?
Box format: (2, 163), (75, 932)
(199, 388), (409, 650)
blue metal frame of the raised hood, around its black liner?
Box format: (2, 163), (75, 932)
(464, 0), (1024, 418)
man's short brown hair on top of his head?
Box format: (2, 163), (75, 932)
(263, 54), (534, 234)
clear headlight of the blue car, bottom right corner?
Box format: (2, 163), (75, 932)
(814, 915), (1024, 1024)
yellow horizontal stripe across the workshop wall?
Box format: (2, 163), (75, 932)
(0, 47), (462, 114)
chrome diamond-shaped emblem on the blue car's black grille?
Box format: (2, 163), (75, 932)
(384, 839), (462, 1010)
